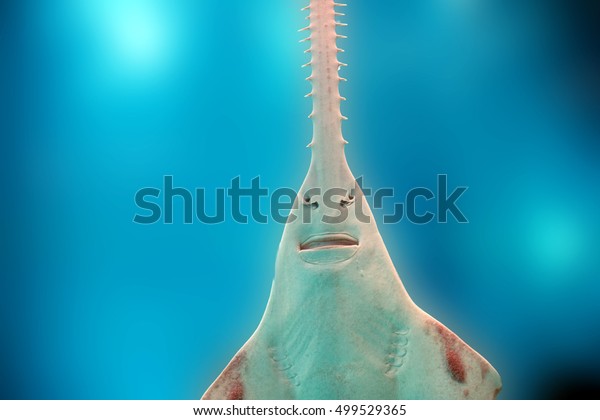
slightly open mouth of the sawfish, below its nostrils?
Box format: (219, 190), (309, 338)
(298, 233), (358, 265)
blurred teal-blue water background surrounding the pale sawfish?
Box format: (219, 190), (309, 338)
(0, 0), (600, 399)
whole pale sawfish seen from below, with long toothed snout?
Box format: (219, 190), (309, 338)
(203, 0), (501, 400)
